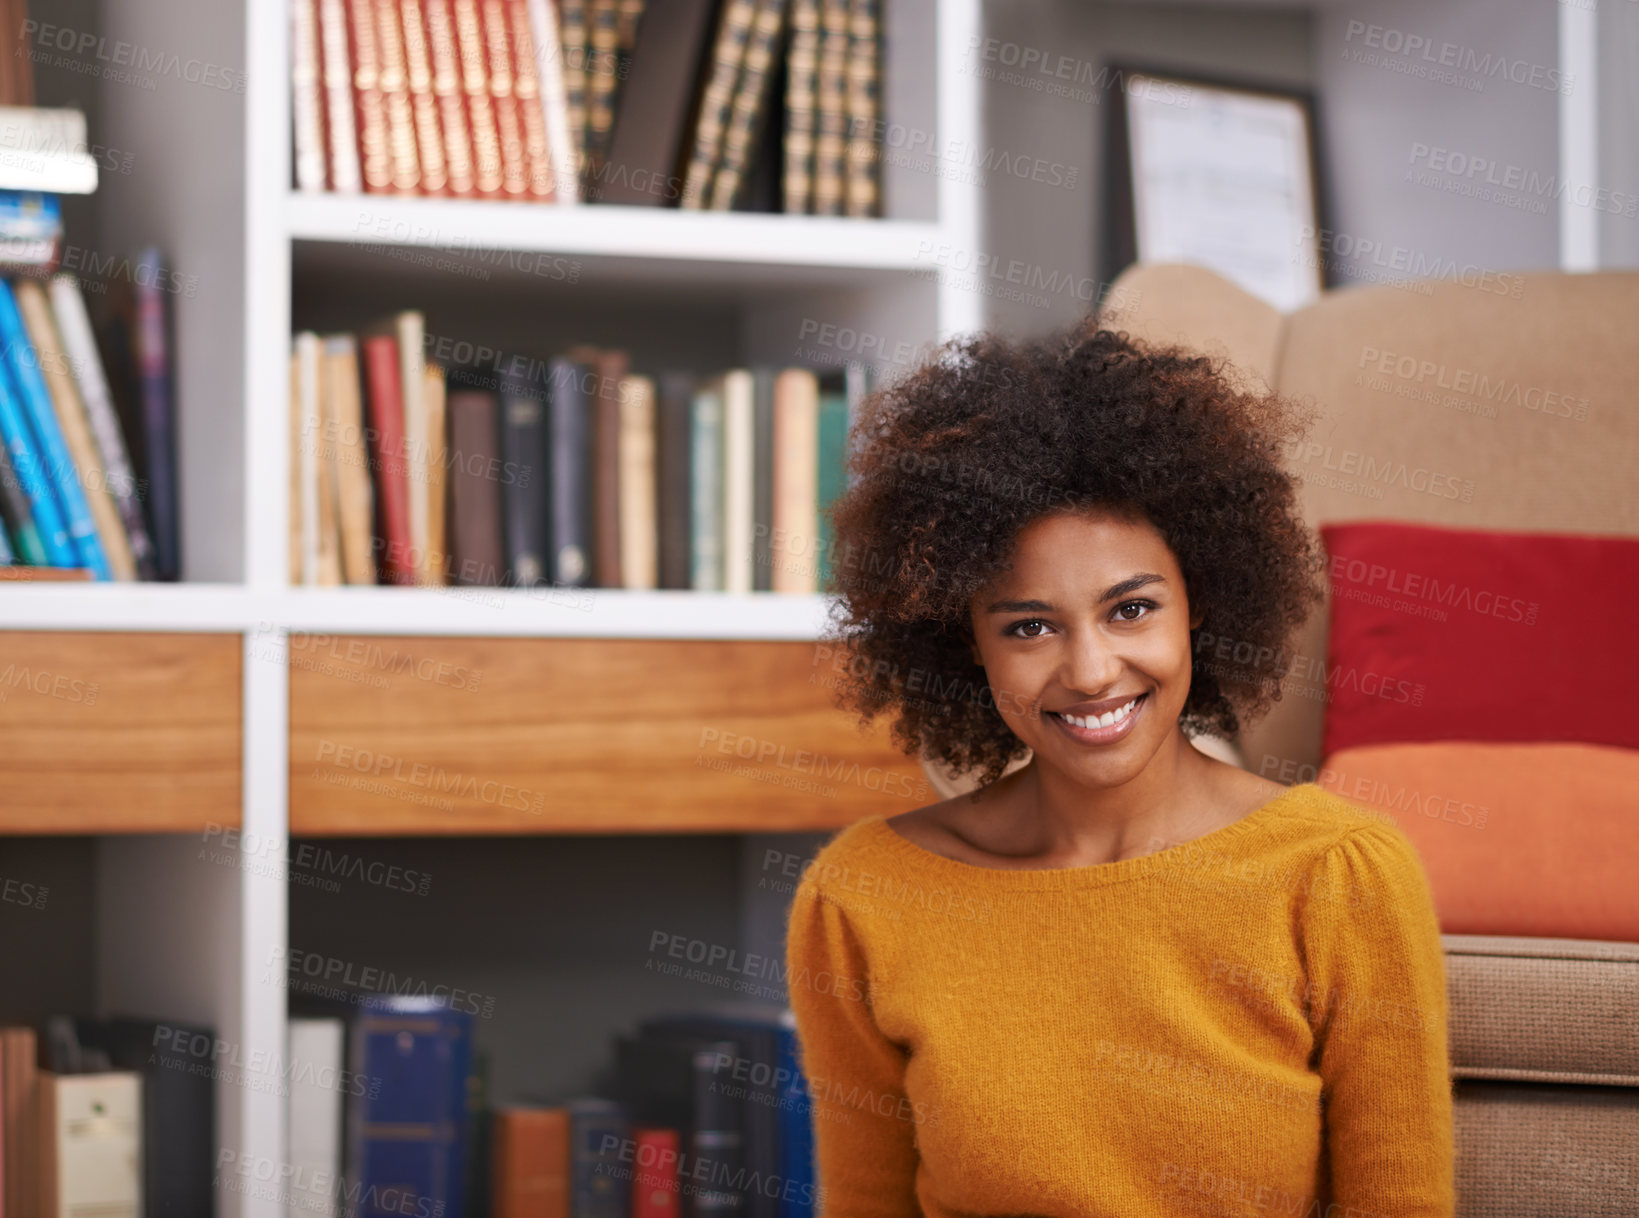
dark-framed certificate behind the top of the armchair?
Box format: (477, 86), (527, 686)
(1105, 67), (1324, 311)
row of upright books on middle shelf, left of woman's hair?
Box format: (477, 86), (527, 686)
(290, 311), (867, 593)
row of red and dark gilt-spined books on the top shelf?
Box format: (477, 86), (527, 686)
(290, 0), (882, 216)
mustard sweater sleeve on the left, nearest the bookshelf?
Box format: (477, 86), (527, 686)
(785, 880), (921, 1218)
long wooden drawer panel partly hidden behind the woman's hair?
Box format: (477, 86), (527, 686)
(290, 636), (933, 836)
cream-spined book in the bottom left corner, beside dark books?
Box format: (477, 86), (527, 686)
(36, 1070), (141, 1218)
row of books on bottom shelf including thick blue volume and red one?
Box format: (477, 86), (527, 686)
(284, 995), (818, 1218)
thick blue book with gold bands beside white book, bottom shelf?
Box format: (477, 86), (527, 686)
(347, 993), (472, 1218)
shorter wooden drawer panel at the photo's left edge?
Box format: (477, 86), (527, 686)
(0, 631), (243, 833)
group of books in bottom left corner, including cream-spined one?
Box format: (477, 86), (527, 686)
(0, 1016), (216, 1218)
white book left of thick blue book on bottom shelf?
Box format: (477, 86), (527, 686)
(285, 1016), (345, 1218)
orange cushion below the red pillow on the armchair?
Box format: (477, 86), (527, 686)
(1318, 741), (1639, 943)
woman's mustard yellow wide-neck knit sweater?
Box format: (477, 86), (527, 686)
(787, 784), (1454, 1218)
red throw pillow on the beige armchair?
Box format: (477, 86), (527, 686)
(1319, 521), (1639, 756)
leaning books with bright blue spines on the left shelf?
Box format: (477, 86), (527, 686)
(0, 260), (180, 580)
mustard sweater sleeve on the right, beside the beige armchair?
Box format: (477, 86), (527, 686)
(1301, 825), (1455, 1218)
